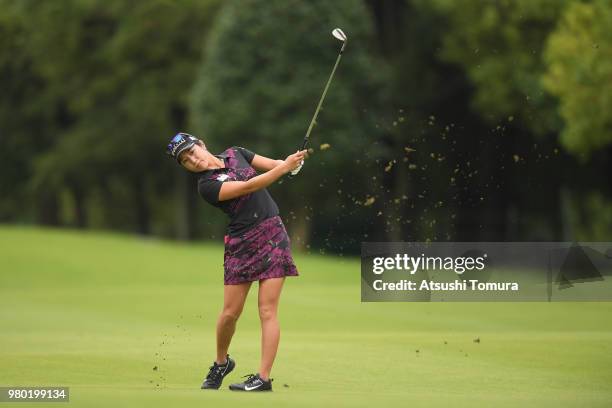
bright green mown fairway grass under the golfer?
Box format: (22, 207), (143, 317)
(0, 226), (612, 408)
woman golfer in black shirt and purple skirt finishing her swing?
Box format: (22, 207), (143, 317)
(168, 133), (306, 391)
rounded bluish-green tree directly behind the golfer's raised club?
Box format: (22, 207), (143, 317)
(192, 0), (378, 249)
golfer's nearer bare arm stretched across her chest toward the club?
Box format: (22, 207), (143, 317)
(219, 150), (306, 201)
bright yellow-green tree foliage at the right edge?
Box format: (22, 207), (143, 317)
(543, 1), (612, 156)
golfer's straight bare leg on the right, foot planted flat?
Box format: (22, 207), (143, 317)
(258, 277), (285, 380)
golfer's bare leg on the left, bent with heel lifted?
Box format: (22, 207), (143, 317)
(216, 282), (251, 364)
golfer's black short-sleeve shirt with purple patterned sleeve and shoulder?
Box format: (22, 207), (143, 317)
(198, 146), (278, 237)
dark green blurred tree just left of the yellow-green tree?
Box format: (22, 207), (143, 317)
(432, 0), (568, 135)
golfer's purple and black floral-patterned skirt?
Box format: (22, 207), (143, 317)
(223, 216), (299, 285)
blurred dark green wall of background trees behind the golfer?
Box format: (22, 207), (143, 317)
(0, 0), (612, 253)
